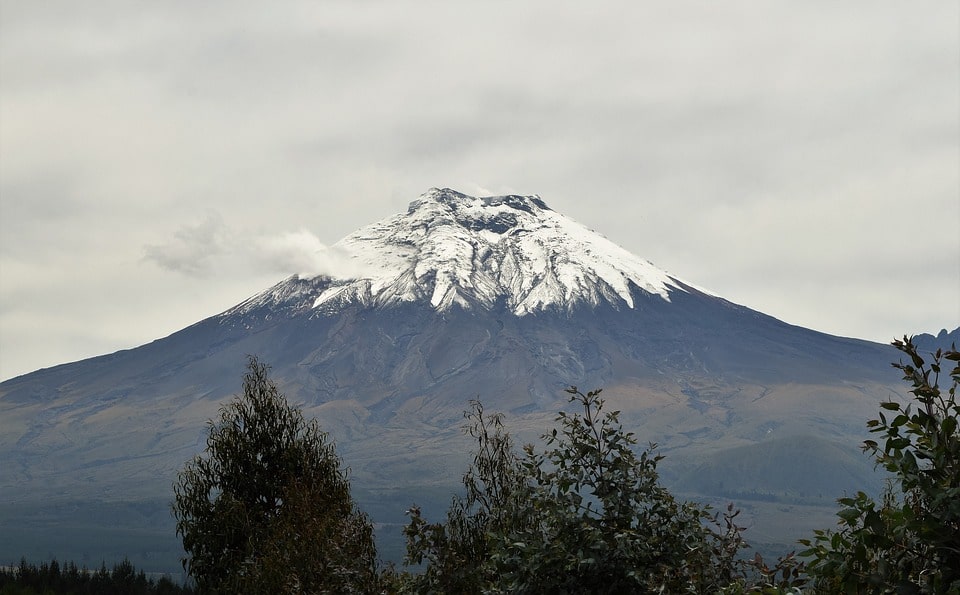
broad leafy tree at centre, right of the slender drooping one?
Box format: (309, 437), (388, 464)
(493, 387), (742, 593)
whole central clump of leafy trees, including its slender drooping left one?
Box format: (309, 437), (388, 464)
(406, 387), (803, 593)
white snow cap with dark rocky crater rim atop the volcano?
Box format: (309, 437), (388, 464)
(304, 188), (685, 315)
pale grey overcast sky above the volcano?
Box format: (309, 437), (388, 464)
(0, 0), (960, 379)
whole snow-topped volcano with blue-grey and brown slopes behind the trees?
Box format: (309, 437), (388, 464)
(0, 189), (924, 570)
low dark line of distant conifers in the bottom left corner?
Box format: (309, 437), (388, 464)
(0, 559), (193, 595)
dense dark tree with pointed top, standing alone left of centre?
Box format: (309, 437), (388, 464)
(173, 357), (376, 593)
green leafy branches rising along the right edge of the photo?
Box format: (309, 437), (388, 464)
(801, 337), (960, 593)
